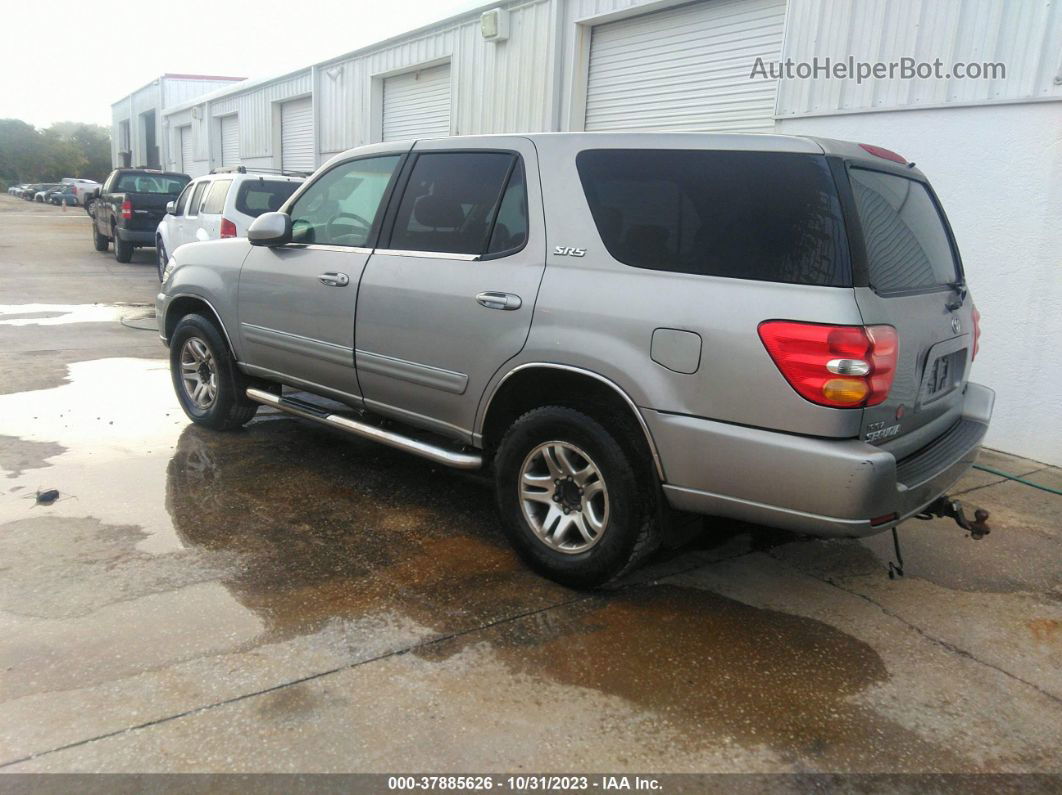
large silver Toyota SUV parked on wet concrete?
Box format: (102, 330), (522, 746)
(157, 134), (994, 586)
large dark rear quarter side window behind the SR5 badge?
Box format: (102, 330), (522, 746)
(577, 150), (852, 287)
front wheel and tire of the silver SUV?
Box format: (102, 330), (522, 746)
(170, 314), (258, 431)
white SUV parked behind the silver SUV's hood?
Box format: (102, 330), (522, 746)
(155, 166), (305, 281)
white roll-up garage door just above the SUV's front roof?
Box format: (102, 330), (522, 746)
(383, 64), (450, 141)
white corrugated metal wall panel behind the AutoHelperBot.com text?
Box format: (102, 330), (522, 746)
(777, 0), (1062, 118)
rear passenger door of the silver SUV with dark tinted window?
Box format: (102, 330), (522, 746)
(356, 137), (546, 438)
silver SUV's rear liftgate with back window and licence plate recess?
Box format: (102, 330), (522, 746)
(846, 162), (974, 457)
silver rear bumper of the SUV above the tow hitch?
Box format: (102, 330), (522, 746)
(643, 383), (995, 537)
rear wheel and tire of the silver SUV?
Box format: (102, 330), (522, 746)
(494, 405), (658, 588)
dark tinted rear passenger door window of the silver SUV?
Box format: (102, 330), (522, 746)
(389, 152), (527, 255)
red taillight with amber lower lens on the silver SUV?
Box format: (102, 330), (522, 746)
(759, 321), (900, 409)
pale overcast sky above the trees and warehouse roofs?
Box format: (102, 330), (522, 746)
(0, 0), (485, 127)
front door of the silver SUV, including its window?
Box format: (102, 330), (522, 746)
(239, 144), (406, 400)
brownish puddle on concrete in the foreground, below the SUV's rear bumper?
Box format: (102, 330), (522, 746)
(417, 585), (964, 770)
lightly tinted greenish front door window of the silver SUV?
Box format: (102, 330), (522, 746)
(291, 155), (401, 246)
